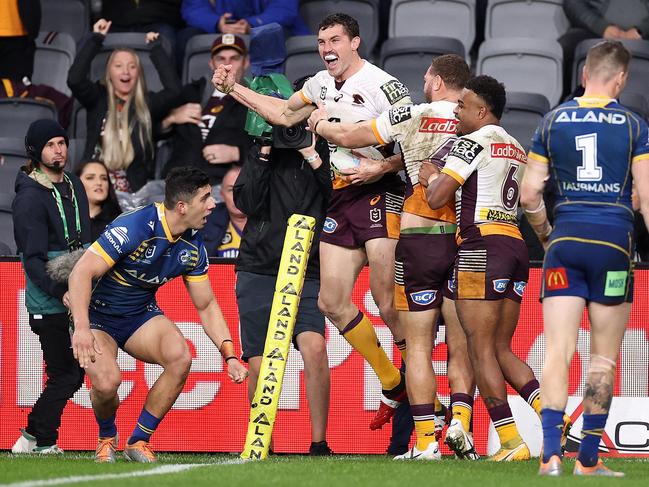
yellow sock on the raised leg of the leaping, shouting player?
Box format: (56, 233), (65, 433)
(340, 311), (401, 390)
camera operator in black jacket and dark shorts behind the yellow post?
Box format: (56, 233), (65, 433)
(234, 136), (332, 455)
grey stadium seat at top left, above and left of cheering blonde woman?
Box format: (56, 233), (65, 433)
(41, 0), (90, 43)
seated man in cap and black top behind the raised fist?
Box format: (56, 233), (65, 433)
(163, 34), (251, 185)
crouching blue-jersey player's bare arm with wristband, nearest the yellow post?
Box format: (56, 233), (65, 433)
(185, 279), (248, 384)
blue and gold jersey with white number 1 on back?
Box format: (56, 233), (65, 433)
(528, 97), (649, 229)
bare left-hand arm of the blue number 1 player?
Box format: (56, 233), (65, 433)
(521, 157), (552, 247)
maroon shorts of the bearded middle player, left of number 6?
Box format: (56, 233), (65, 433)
(394, 232), (457, 311)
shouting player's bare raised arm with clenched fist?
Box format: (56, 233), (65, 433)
(212, 64), (313, 127)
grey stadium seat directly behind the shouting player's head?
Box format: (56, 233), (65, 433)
(300, 0), (379, 56)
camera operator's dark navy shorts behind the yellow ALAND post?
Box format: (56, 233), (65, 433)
(235, 271), (325, 362)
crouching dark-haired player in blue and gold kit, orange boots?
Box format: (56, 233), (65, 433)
(69, 167), (248, 463)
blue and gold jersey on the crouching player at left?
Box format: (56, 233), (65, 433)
(90, 203), (209, 316)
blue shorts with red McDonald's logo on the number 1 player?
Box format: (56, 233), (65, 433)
(541, 222), (633, 305)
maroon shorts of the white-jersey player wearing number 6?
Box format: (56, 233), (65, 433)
(454, 235), (530, 303)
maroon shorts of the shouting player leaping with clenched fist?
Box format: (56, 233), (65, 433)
(320, 182), (403, 248)
